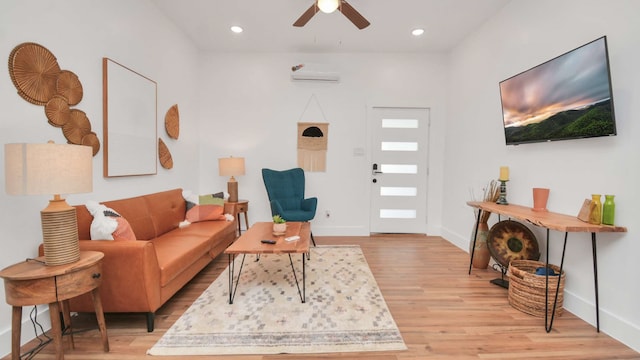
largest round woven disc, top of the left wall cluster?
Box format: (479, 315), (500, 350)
(9, 43), (60, 105)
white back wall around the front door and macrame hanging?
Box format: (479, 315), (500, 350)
(200, 53), (447, 235)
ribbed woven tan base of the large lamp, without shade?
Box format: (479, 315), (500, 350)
(40, 199), (80, 266)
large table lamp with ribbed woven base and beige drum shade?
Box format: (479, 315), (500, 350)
(4, 142), (93, 266)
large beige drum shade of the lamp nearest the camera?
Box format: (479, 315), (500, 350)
(4, 143), (93, 195)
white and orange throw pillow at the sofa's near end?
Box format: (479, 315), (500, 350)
(86, 201), (136, 241)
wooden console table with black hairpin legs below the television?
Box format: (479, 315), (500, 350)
(467, 201), (627, 332)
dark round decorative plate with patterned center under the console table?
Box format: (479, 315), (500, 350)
(487, 220), (540, 267)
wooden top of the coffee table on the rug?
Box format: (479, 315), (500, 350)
(224, 221), (311, 254)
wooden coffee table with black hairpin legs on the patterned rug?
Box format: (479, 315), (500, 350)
(224, 222), (311, 304)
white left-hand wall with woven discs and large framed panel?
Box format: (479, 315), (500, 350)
(0, 0), (199, 354)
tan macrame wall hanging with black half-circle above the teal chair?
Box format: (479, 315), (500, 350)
(298, 94), (329, 172)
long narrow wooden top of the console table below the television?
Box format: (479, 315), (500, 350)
(467, 201), (627, 233)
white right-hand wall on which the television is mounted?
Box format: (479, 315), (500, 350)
(443, 0), (640, 350)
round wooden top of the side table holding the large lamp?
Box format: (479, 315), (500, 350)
(0, 251), (104, 280)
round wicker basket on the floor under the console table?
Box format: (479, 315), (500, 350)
(509, 260), (566, 317)
